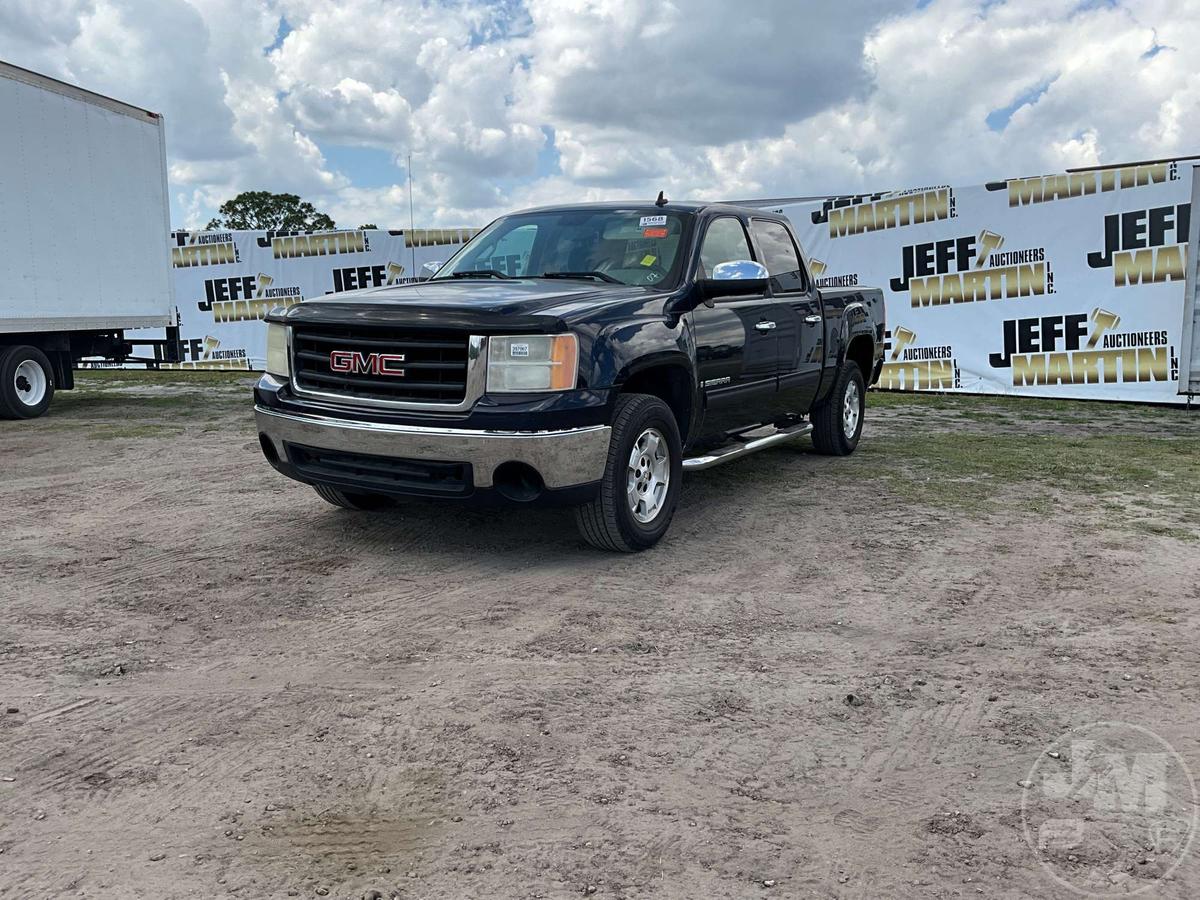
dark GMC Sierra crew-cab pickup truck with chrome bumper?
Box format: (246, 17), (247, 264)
(254, 197), (884, 551)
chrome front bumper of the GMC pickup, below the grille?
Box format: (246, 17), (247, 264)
(254, 406), (612, 490)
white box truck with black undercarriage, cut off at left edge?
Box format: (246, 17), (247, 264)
(0, 62), (178, 419)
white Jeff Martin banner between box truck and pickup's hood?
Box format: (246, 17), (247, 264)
(146, 228), (475, 370)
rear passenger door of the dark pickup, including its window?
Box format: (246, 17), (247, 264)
(750, 218), (826, 414)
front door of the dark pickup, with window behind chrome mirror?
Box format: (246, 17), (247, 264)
(691, 216), (780, 433)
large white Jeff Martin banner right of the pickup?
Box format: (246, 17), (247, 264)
(775, 162), (1192, 403)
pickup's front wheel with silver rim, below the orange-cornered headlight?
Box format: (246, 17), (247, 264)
(575, 394), (683, 553)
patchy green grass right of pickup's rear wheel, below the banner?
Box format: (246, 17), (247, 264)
(859, 391), (1200, 541)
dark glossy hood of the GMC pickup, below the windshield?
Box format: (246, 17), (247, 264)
(270, 278), (656, 334)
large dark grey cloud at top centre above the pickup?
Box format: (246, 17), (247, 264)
(528, 0), (902, 144)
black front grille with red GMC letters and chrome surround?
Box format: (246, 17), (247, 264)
(292, 325), (469, 404)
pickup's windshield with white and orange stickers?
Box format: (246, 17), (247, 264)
(436, 206), (690, 287)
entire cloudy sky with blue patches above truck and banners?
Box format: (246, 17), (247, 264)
(0, 0), (1200, 228)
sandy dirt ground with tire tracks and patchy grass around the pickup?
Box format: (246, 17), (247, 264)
(0, 376), (1200, 899)
